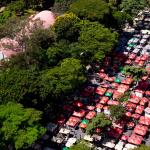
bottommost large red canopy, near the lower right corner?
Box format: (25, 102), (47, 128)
(128, 134), (143, 145)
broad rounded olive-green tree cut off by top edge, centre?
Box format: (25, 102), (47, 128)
(70, 0), (109, 21)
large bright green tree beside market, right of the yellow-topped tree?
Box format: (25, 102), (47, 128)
(71, 21), (118, 61)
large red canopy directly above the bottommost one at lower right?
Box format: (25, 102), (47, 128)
(134, 124), (148, 136)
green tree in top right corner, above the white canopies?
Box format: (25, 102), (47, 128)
(120, 0), (147, 16)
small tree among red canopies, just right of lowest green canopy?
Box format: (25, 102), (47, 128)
(86, 113), (111, 134)
